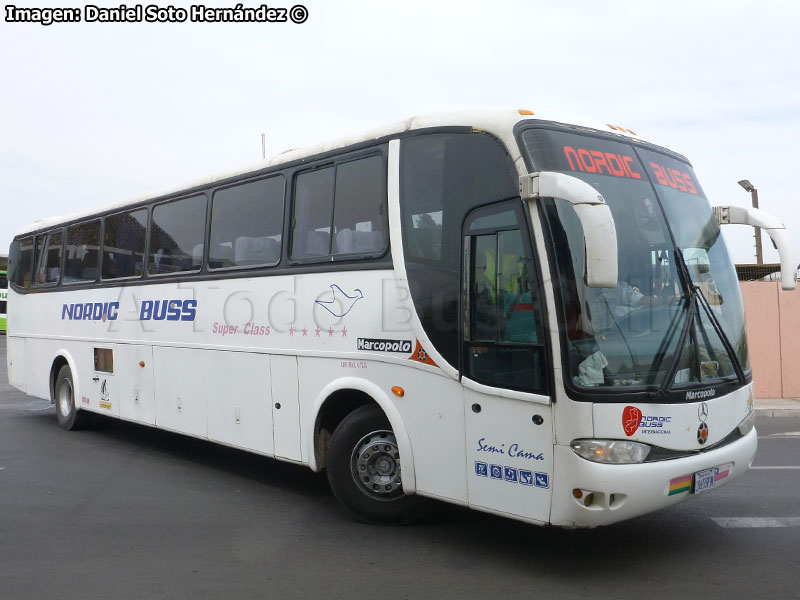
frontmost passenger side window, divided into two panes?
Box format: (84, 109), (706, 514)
(291, 155), (387, 259)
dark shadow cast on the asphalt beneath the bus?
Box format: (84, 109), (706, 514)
(23, 411), (730, 581)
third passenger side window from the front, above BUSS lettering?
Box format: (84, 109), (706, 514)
(147, 195), (206, 275)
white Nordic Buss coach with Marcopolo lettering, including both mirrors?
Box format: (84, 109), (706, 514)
(8, 110), (795, 527)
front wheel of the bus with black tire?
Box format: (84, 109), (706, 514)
(327, 405), (429, 525)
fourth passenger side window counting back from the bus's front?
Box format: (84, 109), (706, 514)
(103, 208), (147, 279)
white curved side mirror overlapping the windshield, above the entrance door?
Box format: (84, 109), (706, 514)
(519, 171), (617, 288)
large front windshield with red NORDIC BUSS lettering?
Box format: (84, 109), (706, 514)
(522, 129), (749, 392)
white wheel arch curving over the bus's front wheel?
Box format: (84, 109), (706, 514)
(306, 377), (417, 493)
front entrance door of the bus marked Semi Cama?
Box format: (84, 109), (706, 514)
(462, 201), (553, 522)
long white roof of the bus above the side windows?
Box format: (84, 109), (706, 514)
(15, 109), (672, 237)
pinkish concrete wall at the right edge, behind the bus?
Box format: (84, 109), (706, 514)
(741, 281), (800, 398)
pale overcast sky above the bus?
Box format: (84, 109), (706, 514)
(0, 0), (800, 263)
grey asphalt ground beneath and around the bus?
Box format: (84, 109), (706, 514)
(0, 338), (800, 600)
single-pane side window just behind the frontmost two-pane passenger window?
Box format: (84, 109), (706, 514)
(208, 176), (286, 269)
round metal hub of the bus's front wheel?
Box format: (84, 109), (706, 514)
(351, 431), (403, 500)
